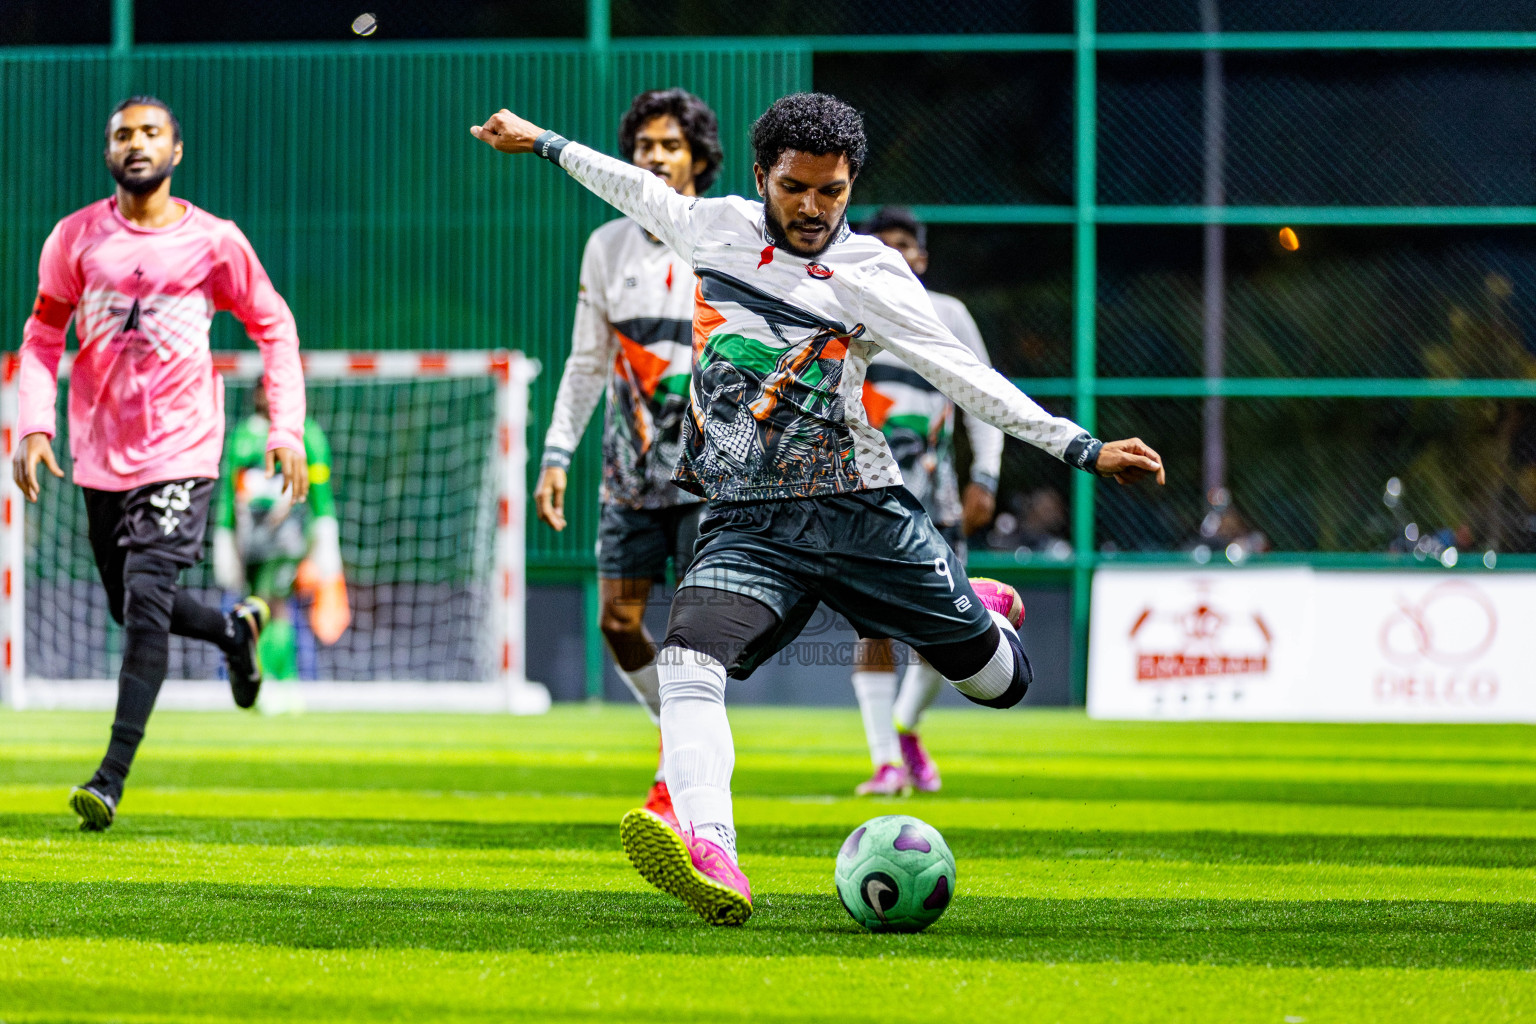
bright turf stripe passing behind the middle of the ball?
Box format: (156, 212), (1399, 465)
(0, 837), (1536, 903)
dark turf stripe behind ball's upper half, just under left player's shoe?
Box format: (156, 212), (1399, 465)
(14, 814), (1536, 869)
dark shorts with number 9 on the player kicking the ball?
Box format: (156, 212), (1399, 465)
(679, 487), (992, 679)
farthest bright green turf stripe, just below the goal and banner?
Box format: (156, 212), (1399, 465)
(12, 709), (1536, 765)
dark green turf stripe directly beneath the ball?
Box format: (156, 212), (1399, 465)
(0, 883), (1536, 976)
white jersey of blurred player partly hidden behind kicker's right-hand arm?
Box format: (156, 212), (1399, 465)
(863, 292), (1003, 527)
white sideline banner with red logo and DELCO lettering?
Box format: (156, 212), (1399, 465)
(1087, 570), (1536, 722)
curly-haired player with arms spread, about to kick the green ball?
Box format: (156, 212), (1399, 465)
(472, 94), (1163, 924)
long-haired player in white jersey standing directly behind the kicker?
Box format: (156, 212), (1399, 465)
(533, 89), (720, 821)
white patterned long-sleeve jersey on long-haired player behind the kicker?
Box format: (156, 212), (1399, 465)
(542, 218), (697, 508)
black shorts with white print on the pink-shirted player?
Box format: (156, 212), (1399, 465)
(80, 477), (214, 573)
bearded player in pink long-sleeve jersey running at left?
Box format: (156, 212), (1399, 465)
(12, 97), (309, 831)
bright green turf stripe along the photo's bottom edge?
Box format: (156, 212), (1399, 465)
(0, 936), (1536, 1024)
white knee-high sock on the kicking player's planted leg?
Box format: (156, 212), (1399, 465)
(656, 646), (736, 860)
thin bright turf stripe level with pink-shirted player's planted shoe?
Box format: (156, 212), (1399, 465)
(0, 785), (1536, 838)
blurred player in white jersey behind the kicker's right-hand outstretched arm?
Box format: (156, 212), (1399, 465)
(852, 206), (1003, 797)
